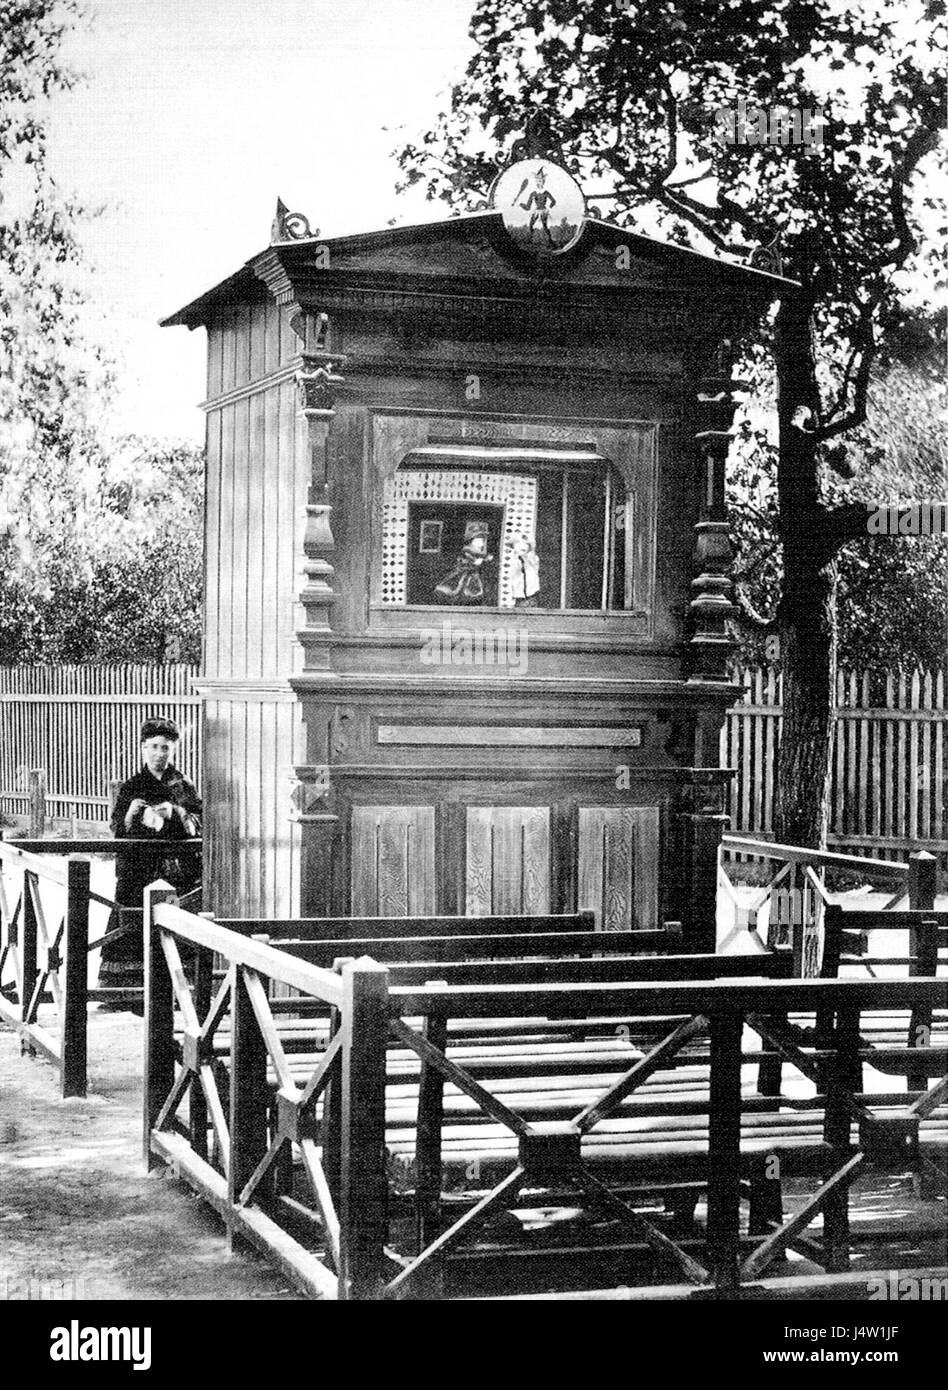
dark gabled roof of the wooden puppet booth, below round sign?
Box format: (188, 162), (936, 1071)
(161, 210), (798, 328)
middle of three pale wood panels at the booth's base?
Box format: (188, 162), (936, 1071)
(466, 806), (550, 917)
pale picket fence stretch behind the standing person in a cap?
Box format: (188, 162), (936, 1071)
(0, 663), (202, 821)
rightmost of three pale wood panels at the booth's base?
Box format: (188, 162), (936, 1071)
(578, 806), (660, 931)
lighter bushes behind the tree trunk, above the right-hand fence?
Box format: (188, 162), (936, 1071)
(727, 314), (948, 673)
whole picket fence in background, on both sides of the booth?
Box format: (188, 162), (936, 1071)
(0, 664), (948, 858)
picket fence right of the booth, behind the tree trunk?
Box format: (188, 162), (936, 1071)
(721, 667), (948, 859)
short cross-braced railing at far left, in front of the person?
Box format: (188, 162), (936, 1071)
(0, 840), (202, 1097)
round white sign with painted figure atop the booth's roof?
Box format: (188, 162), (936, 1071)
(491, 160), (587, 256)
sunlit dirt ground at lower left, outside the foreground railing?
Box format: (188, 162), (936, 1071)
(0, 1011), (297, 1300)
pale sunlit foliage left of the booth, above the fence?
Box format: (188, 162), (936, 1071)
(0, 0), (202, 662)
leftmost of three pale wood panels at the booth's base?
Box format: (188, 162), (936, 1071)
(350, 806), (438, 917)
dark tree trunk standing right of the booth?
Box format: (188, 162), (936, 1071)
(774, 296), (837, 849)
